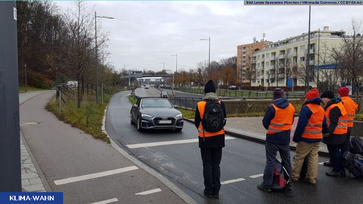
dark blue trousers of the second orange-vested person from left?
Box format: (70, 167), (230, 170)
(261, 142), (292, 189)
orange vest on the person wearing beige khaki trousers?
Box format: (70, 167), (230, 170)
(301, 103), (325, 139)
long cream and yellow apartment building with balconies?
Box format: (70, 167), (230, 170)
(251, 26), (345, 87)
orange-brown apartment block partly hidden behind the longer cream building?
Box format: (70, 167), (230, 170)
(237, 38), (271, 85)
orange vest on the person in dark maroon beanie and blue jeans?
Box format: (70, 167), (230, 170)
(267, 103), (295, 134)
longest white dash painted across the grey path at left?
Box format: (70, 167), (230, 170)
(54, 166), (138, 185)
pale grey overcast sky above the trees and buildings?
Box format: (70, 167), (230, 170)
(55, 1), (363, 71)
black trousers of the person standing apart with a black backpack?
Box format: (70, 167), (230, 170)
(200, 148), (222, 195)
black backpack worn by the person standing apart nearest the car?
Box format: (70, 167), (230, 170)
(202, 100), (225, 132)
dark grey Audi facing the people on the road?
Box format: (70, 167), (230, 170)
(130, 97), (184, 132)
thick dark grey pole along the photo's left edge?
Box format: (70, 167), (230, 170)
(0, 1), (22, 192)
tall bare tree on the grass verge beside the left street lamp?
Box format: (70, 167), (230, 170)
(60, 1), (107, 107)
